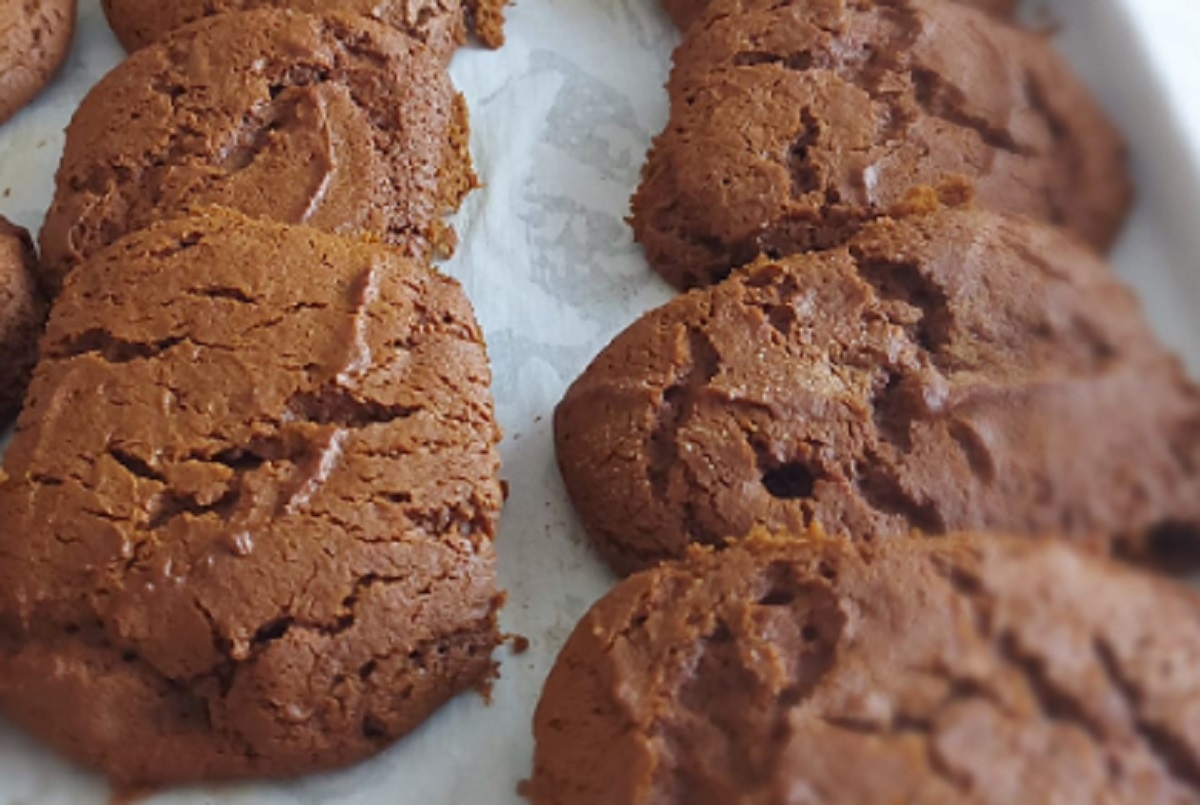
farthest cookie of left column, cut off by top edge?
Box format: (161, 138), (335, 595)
(102, 0), (466, 61)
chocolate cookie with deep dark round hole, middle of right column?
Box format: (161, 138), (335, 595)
(554, 211), (1200, 572)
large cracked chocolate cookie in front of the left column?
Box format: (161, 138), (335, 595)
(0, 207), (502, 786)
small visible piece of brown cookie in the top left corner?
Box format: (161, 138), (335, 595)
(0, 0), (76, 124)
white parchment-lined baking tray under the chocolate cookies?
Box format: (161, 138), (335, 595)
(0, 0), (1200, 805)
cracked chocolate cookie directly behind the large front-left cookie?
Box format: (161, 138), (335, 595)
(34, 10), (475, 297)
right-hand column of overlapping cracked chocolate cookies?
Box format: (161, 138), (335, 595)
(527, 0), (1200, 805)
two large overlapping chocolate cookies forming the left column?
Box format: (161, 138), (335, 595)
(0, 2), (503, 788)
